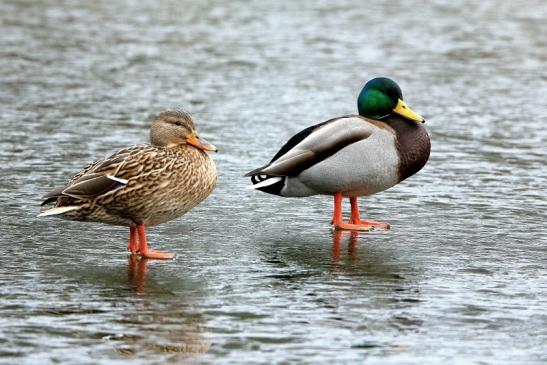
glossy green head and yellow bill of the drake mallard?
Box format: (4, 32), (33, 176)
(357, 77), (424, 122)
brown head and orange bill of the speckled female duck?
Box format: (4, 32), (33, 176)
(150, 109), (217, 152)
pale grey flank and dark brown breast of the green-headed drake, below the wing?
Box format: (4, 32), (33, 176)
(281, 116), (431, 196)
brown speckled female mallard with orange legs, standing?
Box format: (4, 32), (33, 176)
(39, 109), (217, 259)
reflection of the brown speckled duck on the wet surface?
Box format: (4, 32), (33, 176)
(46, 255), (212, 356)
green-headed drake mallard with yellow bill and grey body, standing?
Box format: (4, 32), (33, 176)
(246, 77), (431, 231)
